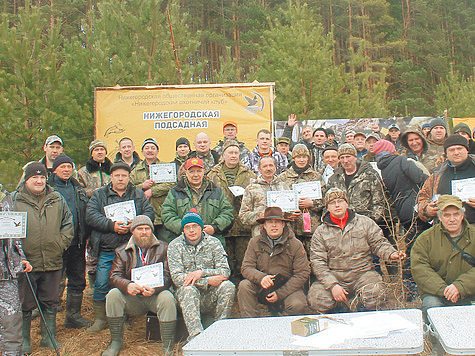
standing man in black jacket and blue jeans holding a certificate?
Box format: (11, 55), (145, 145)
(86, 162), (154, 333)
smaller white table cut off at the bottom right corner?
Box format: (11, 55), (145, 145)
(427, 305), (475, 355)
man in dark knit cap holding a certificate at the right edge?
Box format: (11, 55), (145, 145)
(417, 134), (475, 224)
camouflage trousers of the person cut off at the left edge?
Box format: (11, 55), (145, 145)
(0, 279), (23, 355)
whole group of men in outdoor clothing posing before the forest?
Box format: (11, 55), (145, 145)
(0, 115), (475, 356)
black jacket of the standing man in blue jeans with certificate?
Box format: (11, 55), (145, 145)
(86, 183), (155, 256)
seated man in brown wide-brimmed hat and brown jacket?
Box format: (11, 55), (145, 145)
(238, 207), (310, 318)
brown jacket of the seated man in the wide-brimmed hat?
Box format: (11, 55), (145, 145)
(241, 226), (310, 300)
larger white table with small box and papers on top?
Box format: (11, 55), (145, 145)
(183, 309), (424, 356)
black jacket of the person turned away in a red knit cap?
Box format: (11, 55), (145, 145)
(378, 153), (428, 224)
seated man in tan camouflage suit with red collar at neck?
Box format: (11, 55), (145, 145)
(307, 188), (406, 313)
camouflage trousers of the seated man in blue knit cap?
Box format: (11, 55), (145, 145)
(175, 281), (236, 339)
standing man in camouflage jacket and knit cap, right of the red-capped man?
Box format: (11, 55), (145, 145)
(208, 140), (256, 276)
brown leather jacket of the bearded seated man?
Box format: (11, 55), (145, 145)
(109, 236), (172, 294)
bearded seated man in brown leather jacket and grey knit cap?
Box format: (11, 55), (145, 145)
(102, 215), (176, 356)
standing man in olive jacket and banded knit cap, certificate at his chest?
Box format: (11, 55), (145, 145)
(130, 138), (176, 241)
